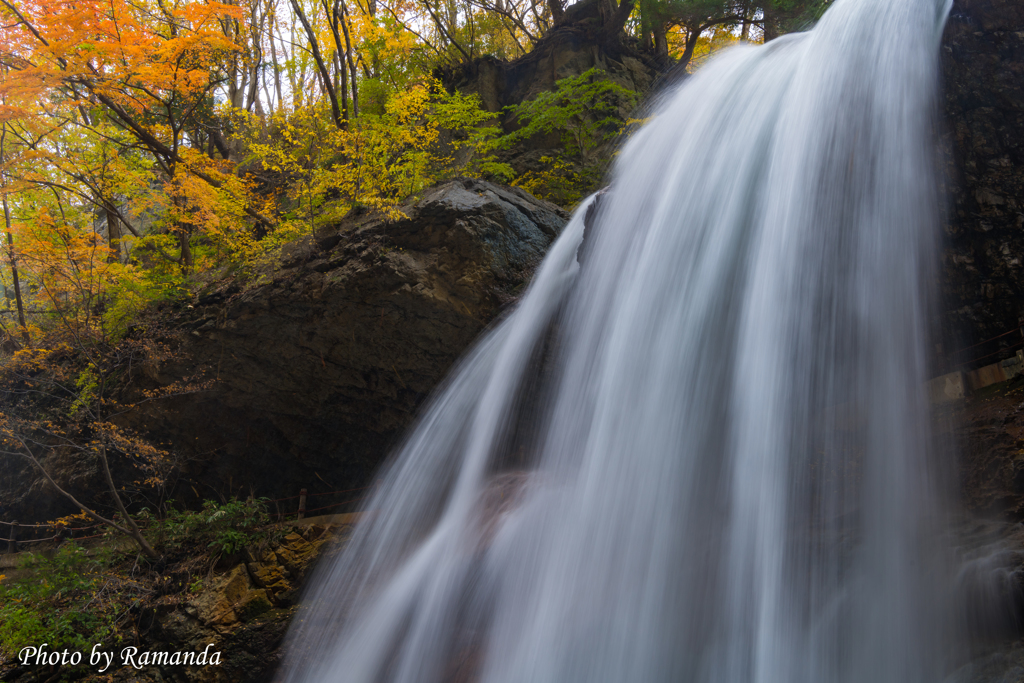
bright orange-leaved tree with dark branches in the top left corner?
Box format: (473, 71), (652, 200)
(0, 0), (270, 269)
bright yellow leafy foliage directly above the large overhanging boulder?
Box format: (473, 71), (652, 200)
(232, 82), (497, 260)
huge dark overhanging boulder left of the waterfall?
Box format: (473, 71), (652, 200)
(129, 180), (566, 512)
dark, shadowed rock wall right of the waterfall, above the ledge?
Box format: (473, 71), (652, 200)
(942, 0), (1024, 365)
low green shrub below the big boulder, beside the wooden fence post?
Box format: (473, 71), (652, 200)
(162, 498), (270, 555)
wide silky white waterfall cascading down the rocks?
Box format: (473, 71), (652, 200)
(283, 0), (950, 683)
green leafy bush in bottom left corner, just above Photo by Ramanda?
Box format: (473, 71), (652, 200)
(0, 544), (120, 656)
